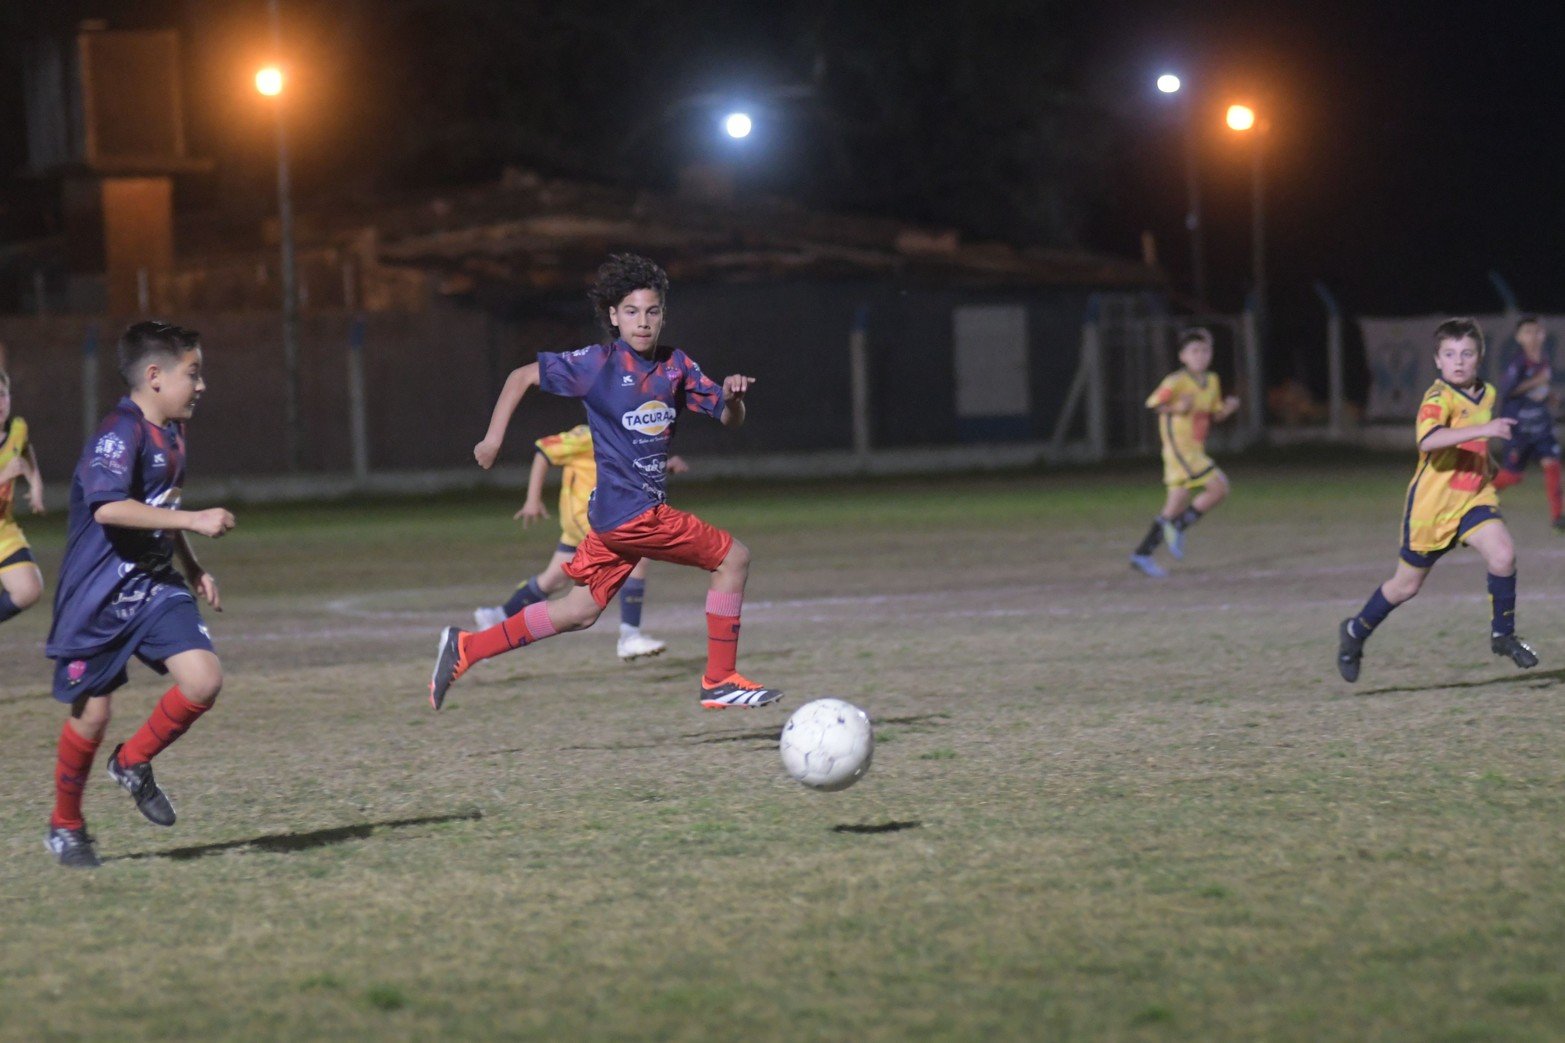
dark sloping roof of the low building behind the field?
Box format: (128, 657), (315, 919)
(352, 172), (1164, 291)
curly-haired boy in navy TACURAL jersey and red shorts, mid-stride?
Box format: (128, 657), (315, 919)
(429, 254), (783, 709)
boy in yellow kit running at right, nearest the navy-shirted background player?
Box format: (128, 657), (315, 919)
(1337, 318), (1538, 681)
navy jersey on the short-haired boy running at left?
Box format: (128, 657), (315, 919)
(45, 398), (192, 659)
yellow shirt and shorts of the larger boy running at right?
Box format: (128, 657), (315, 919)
(1402, 381), (1499, 551)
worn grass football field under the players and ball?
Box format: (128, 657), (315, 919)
(0, 460), (1565, 1041)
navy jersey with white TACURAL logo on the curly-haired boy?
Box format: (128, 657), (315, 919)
(538, 340), (723, 532)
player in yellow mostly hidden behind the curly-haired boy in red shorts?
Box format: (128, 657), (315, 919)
(473, 424), (690, 661)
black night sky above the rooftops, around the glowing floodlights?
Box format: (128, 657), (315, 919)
(0, 0), (1565, 385)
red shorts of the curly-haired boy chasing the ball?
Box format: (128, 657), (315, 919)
(565, 503), (734, 608)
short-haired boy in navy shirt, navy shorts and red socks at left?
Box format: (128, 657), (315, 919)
(45, 321), (233, 868)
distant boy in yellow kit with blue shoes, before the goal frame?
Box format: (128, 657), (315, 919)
(1130, 327), (1239, 578)
